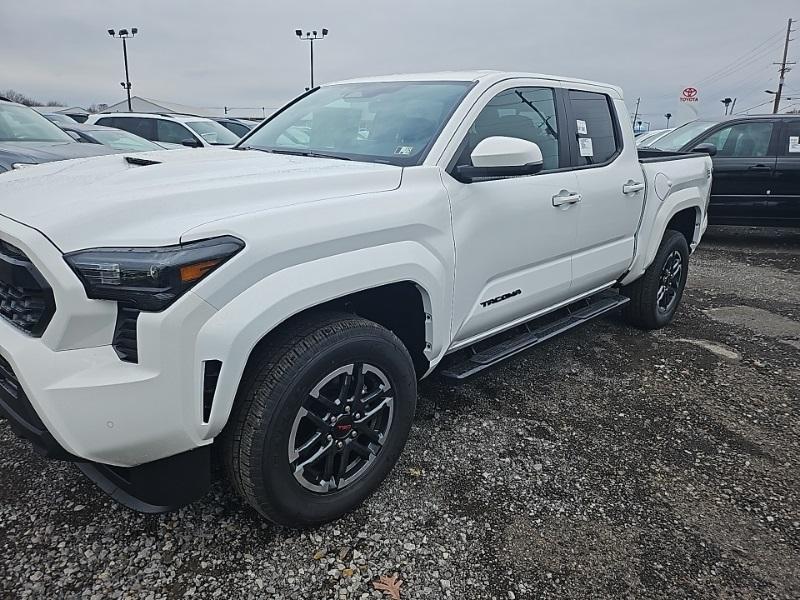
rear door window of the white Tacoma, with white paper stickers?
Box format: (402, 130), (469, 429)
(569, 90), (621, 166)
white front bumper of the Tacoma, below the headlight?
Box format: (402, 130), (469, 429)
(0, 217), (219, 467)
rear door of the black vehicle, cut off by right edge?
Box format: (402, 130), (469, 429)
(765, 117), (800, 225)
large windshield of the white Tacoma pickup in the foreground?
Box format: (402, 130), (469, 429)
(242, 81), (470, 166)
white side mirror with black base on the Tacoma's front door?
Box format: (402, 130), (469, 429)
(456, 136), (543, 183)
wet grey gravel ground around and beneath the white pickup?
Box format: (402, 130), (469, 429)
(0, 228), (800, 600)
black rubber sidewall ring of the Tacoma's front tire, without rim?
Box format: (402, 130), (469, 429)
(250, 328), (416, 525)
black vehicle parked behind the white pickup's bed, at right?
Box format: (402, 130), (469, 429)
(655, 115), (800, 227)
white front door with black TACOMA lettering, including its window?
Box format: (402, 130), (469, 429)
(444, 86), (579, 345)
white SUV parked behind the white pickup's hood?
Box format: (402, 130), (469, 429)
(86, 113), (239, 148)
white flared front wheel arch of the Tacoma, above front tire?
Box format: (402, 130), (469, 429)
(195, 243), (452, 439)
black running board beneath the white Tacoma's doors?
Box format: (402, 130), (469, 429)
(441, 292), (629, 380)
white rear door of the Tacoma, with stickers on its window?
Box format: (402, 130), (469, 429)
(566, 90), (645, 294)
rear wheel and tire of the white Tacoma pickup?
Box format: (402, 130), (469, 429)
(621, 229), (689, 329)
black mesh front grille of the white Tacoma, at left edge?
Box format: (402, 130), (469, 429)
(0, 241), (56, 337)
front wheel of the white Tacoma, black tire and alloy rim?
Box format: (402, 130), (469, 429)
(222, 313), (417, 528)
